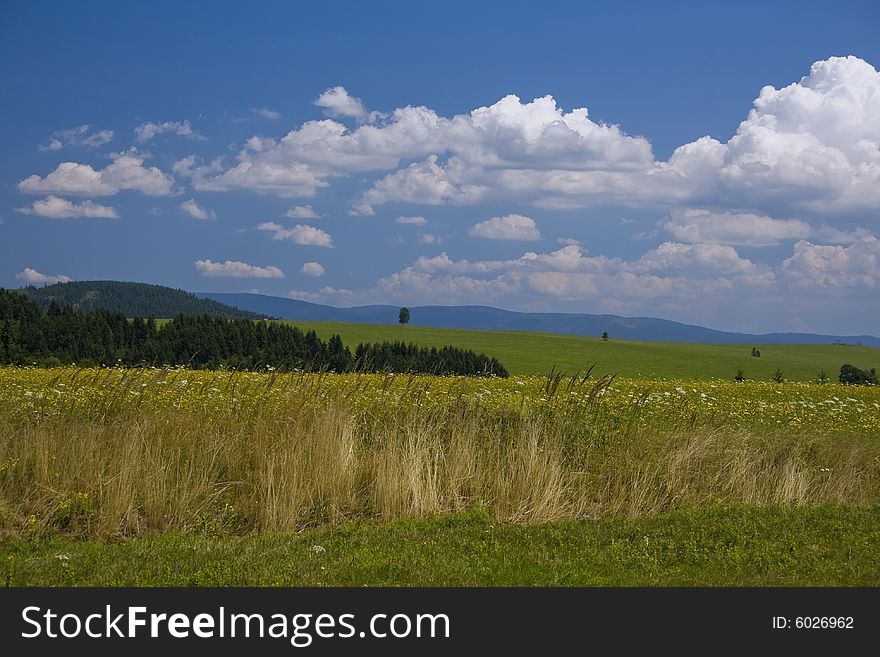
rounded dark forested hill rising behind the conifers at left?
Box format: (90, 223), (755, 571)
(18, 281), (262, 319)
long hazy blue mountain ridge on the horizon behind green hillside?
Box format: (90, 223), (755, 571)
(196, 292), (880, 348)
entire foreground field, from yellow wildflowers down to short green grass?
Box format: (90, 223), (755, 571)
(0, 367), (880, 585)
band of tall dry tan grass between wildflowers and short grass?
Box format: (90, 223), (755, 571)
(0, 368), (880, 537)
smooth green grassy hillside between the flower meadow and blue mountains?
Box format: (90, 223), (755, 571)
(291, 321), (880, 381)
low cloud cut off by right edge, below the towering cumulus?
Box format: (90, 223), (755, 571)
(780, 235), (880, 290)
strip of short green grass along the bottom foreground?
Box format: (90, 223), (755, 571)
(0, 506), (880, 586)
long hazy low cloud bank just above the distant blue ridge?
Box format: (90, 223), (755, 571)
(375, 243), (775, 308)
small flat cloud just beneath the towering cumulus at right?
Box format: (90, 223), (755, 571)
(662, 210), (812, 246)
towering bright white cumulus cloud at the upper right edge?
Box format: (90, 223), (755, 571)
(670, 56), (880, 213)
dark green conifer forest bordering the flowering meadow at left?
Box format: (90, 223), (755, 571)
(0, 289), (507, 376)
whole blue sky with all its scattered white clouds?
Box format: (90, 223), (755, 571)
(0, 1), (880, 335)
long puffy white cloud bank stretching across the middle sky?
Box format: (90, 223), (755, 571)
(190, 87), (652, 204)
